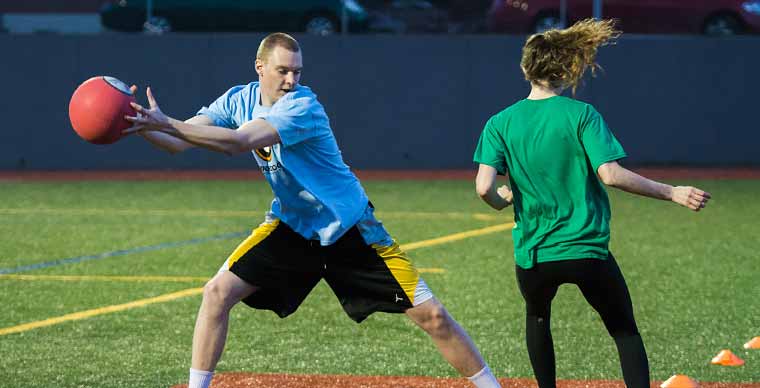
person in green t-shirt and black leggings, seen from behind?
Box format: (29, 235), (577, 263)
(474, 19), (710, 388)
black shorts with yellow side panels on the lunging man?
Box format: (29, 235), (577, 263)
(221, 219), (433, 322)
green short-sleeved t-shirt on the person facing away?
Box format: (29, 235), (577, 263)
(474, 96), (626, 269)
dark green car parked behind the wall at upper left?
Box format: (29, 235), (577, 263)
(100, 0), (369, 35)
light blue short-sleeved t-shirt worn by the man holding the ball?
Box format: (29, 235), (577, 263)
(198, 82), (373, 245)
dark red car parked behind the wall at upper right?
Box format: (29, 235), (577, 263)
(487, 0), (760, 35)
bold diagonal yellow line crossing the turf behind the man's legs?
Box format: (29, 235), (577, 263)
(0, 223), (514, 336)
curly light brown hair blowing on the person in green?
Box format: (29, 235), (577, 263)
(520, 19), (622, 94)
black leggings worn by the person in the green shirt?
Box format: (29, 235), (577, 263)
(516, 254), (649, 388)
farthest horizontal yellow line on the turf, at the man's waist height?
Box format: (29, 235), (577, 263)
(0, 208), (504, 221)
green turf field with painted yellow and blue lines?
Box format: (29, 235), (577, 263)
(0, 180), (760, 388)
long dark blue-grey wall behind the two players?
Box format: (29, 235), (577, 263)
(0, 34), (760, 170)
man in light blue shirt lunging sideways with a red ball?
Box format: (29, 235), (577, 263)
(125, 33), (499, 388)
